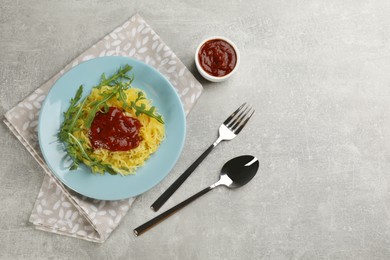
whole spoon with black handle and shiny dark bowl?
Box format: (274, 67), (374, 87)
(134, 155), (259, 236)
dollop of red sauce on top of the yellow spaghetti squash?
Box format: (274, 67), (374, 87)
(89, 107), (142, 152)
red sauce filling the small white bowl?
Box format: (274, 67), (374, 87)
(198, 39), (237, 77)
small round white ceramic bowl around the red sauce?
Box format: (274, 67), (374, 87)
(195, 36), (240, 82)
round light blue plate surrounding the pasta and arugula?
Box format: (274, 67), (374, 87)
(38, 56), (186, 200)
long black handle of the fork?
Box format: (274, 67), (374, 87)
(150, 138), (222, 211)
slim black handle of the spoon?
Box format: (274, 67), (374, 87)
(134, 185), (216, 236)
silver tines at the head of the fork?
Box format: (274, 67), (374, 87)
(223, 102), (255, 134)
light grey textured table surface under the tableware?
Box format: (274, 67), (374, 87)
(0, 0), (390, 259)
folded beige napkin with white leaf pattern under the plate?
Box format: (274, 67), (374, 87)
(4, 14), (202, 243)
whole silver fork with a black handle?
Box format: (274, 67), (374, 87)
(150, 103), (255, 211)
